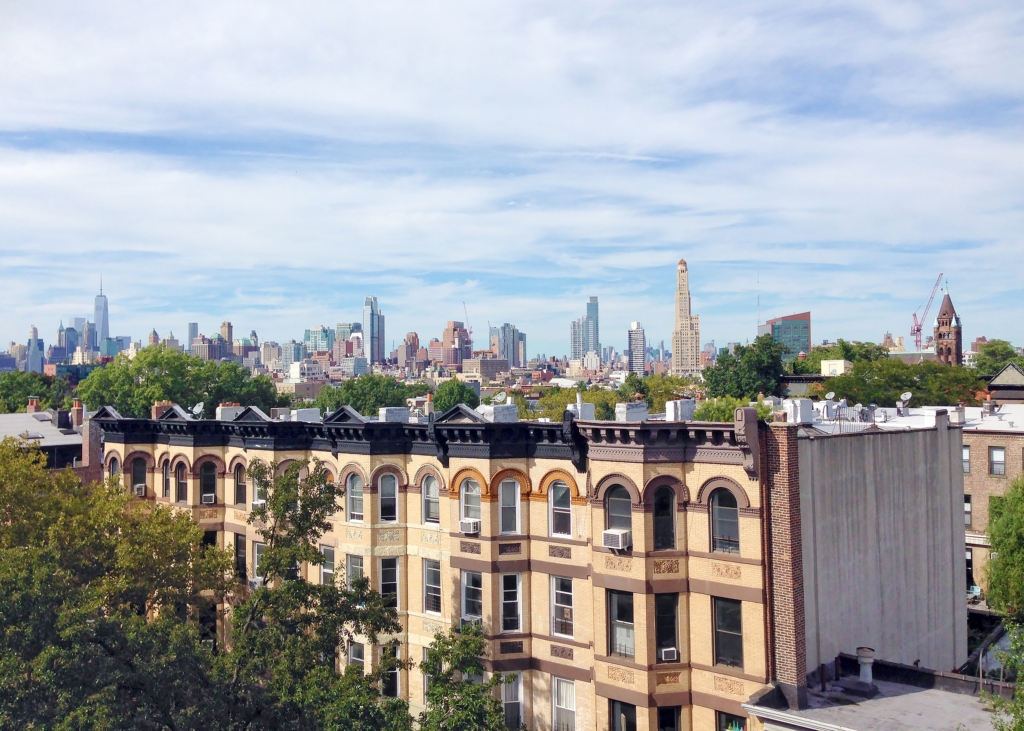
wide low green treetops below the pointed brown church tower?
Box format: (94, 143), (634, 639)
(813, 358), (985, 406)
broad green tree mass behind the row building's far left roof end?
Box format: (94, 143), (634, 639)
(78, 345), (291, 419)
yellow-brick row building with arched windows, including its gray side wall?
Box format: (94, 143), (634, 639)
(95, 405), (967, 731)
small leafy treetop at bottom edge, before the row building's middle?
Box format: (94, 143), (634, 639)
(419, 627), (514, 731)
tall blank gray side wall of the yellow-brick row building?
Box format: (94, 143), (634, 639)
(799, 414), (967, 672)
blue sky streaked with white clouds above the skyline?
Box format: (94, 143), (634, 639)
(0, 1), (1024, 355)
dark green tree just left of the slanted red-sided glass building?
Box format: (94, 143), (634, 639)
(703, 335), (788, 400)
